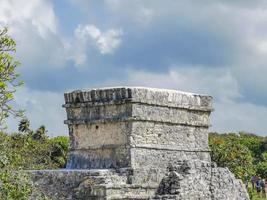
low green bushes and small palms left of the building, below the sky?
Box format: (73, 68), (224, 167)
(0, 119), (69, 200)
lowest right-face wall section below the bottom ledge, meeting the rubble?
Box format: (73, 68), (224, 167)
(130, 148), (213, 184)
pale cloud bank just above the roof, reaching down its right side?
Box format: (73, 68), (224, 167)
(105, 66), (267, 135)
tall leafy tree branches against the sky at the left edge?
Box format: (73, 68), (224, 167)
(0, 28), (23, 128)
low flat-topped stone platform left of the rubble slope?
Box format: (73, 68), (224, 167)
(28, 169), (157, 200)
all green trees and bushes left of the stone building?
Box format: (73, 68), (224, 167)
(0, 28), (68, 200)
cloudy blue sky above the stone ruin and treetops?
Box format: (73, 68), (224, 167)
(0, 0), (267, 136)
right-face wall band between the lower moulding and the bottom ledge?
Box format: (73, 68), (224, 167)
(130, 121), (209, 151)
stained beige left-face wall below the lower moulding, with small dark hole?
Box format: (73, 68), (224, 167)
(67, 122), (131, 169)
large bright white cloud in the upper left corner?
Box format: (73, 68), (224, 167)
(0, 0), (68, 70)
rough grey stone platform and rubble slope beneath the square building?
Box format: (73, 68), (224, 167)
(27, 160), (249, 200)
